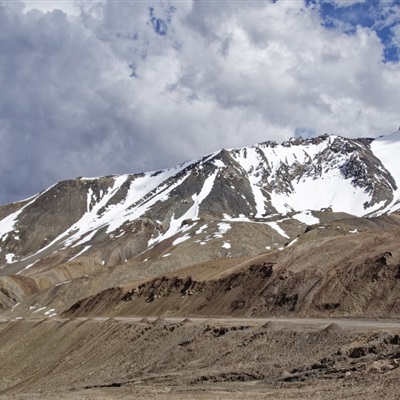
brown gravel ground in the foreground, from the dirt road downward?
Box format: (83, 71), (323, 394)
(0, 318), (400, 400)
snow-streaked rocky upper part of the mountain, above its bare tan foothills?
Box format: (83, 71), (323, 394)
(0, 132), (400, 275)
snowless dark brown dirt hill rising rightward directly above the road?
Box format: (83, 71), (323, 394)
(61, 230), (400, 317)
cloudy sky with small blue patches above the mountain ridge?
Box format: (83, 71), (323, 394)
(0, 0), (400, 204)
